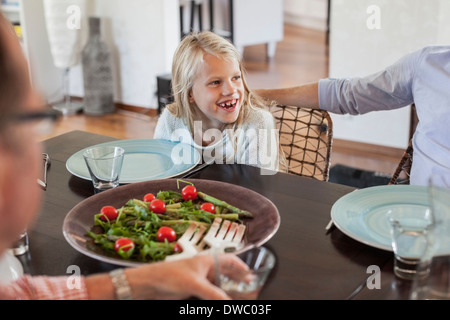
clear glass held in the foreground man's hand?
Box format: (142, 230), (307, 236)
(215, 247), (275, 300)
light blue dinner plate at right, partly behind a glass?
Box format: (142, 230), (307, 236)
(331, 185), (429, 251)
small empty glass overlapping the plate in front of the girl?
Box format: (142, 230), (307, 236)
(83, 146), (125, 193)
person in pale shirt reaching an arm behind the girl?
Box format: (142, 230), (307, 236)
(255, 46), (450, 185)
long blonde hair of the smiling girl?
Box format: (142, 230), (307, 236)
(167, 31), (267, 133)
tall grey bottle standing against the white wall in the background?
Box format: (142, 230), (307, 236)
(81, 17), (115, 115)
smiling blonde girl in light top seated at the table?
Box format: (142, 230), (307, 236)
(154, 31), (279, 174)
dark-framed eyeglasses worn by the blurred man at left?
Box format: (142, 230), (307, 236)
(13, 109), (61, 136)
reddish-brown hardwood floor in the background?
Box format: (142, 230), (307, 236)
(42, 25), (402, 174)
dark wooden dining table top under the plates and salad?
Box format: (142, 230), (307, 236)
(18, 131), (411, 300)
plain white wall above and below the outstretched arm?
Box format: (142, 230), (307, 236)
(329, 0), (450, 148)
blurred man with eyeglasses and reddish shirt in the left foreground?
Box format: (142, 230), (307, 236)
(0, 14), (240, 300)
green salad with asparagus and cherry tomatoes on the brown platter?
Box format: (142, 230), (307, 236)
(88, 180), (252, 262)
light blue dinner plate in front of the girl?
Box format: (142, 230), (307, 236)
(66, 139), (201, 183)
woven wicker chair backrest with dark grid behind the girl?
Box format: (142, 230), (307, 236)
(271, 105), (333, 181)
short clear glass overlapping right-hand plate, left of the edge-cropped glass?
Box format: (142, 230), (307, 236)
(387, 205), (433, 280)
